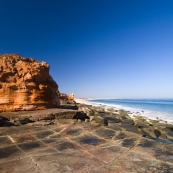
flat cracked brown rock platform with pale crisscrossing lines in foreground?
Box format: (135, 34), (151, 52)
(0, 110), (173, 173)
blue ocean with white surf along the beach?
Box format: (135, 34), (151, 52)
(89, 99), (173, 122)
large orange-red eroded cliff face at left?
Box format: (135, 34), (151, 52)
(0, 54), (59, 112)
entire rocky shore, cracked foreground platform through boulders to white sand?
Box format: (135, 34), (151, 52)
(0, 100), (173, 173)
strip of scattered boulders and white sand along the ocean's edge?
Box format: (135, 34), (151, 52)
(75, 99), (173, 144)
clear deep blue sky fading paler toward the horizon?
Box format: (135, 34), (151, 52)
(0, 0), (173, 98)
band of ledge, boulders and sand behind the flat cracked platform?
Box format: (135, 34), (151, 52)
(0, 99), (173, 144)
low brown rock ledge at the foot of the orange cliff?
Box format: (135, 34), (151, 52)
(0, 106), (85, 126)
